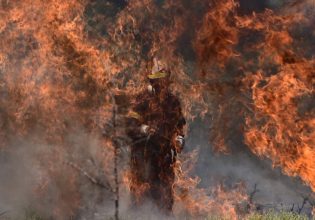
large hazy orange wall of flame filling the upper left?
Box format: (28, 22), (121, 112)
(0, 0), (116, 219)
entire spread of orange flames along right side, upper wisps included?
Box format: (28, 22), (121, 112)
(197, 1), (315, 195)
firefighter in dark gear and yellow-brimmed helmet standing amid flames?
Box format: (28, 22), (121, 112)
(127, 60), (186, 213)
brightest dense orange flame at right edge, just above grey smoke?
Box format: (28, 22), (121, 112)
(245, 62), (315, 190)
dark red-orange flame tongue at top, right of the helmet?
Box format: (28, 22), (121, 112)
(194, 0), (238, 67)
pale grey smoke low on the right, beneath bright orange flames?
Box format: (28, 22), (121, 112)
(186, 119), (312, 213)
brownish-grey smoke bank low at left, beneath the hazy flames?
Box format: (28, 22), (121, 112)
(0, 129), (113, 219)
